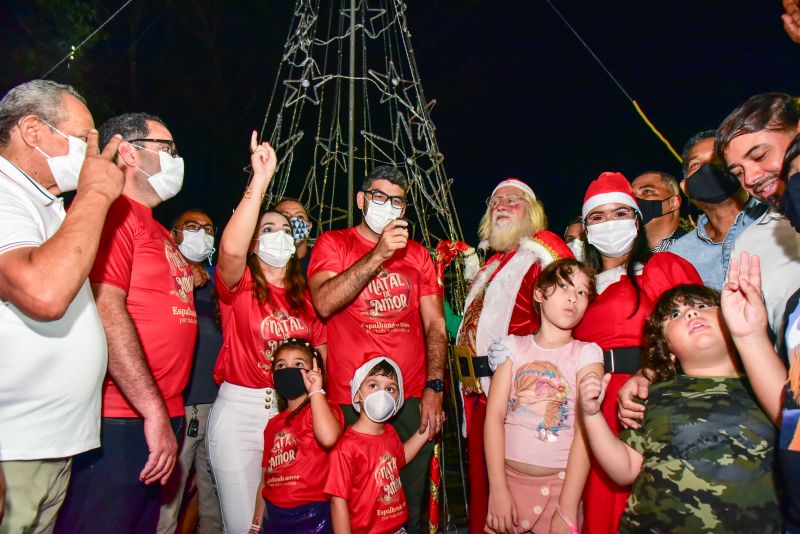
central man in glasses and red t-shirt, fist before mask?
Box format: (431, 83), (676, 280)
(309, 166), (447, 532)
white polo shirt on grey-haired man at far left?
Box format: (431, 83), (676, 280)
(0, 157), (108, 461)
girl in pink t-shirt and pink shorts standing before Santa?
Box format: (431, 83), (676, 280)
(484, 258), (603, 534)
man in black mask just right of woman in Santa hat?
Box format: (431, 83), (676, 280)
(631, 171), (686, 252)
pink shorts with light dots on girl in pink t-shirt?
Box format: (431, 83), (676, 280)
(506, 467), (566, 534)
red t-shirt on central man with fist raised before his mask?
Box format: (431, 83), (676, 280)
(308, 227), (442, 404)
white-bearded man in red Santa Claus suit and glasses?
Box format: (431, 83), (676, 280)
(456, 178), (580, 532)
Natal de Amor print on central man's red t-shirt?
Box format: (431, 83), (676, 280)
(360, 271), (411, 334)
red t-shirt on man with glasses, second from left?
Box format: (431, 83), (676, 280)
(89, 195), (197, 417)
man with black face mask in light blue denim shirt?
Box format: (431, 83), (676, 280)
(670, 130), (767, 291)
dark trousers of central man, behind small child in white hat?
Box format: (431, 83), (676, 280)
(341, 397), (433, 534)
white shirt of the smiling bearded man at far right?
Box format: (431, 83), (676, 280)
(733, 208), (800, 342)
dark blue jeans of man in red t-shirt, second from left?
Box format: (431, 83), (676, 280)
(55, 417), (183, 534)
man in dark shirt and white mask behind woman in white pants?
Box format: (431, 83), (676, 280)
(156, 209), (222, 534)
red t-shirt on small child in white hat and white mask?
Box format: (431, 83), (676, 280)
(325, 425), (408, 534)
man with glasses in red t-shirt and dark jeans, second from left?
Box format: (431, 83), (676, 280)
(56, 113), (197, 532)
